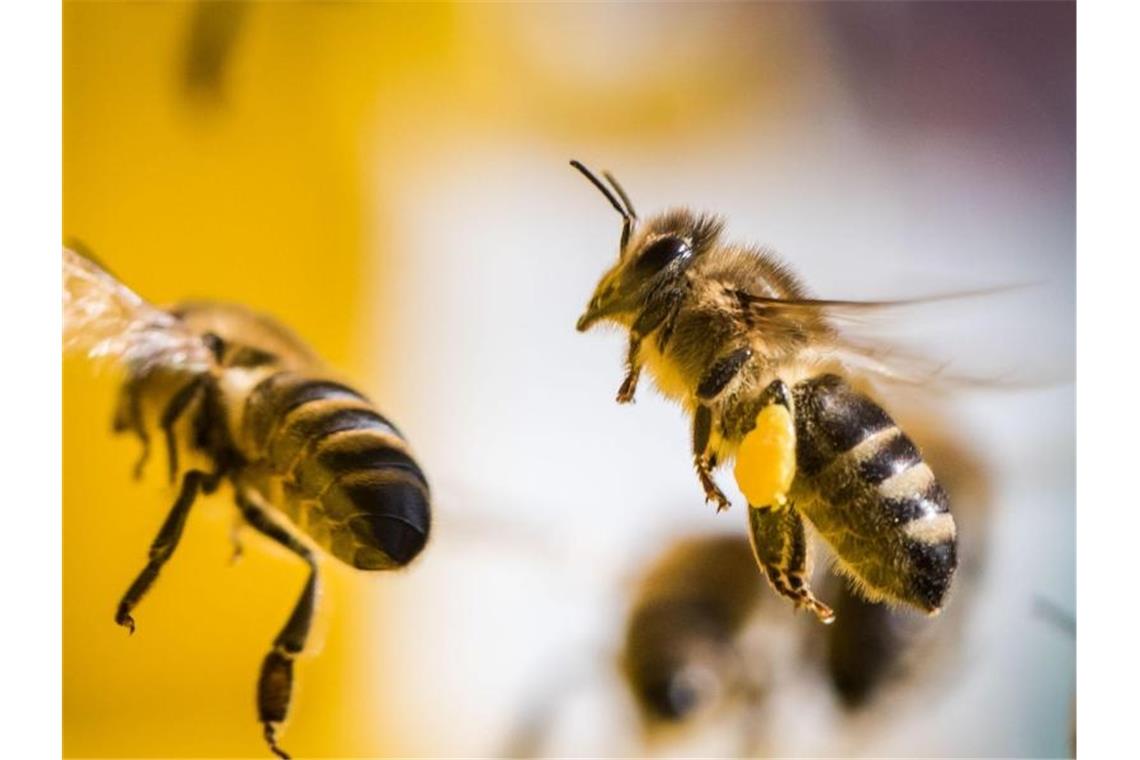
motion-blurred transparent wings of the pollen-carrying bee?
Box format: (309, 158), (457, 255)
(733, 286), (1072, 391)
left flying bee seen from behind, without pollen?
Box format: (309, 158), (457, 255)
(63, 248), (431, 758)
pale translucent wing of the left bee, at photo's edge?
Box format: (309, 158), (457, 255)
(63, 248), (213, 374)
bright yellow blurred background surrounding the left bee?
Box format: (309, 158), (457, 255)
(64, 2), (446, 757)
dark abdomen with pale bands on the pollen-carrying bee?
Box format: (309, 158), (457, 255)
(793, 375), (958, 612)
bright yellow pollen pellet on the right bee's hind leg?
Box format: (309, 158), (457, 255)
(733, 403), (796, 507)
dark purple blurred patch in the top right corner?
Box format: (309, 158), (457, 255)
(816, 2), (1076, 176)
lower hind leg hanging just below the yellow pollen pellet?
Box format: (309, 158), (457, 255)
(748, 504), (836, 623)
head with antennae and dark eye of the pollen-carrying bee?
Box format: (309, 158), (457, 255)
(570, 161), (724, 332)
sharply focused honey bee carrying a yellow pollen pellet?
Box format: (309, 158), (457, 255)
(571, 161), (958, 622)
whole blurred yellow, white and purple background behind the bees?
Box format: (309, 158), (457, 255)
(63, 2), (1075, 757)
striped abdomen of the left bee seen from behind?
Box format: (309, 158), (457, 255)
(241, 371), (431, 570)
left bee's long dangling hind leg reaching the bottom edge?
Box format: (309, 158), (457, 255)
(237, 492), (317, 758)
